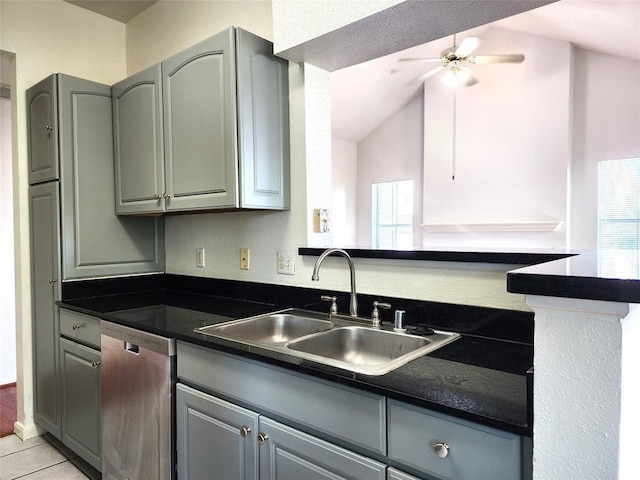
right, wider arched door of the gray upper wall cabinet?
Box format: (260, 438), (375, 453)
(162, 29), (238, 211)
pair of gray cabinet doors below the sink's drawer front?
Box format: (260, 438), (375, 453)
(176, 384), (386, 480)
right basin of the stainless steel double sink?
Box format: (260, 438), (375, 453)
(287, 326), (458, 375)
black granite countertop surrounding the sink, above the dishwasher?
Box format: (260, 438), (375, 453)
(58, 289), (533, 436)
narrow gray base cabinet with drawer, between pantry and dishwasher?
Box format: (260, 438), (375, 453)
(58, 309), (102, 470)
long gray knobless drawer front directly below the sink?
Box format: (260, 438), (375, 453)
(177, 342), (387, 455)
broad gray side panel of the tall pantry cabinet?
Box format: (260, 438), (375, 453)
(58, 75), (164, 280)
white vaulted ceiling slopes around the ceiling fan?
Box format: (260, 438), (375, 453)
(331, 0), (640, 143)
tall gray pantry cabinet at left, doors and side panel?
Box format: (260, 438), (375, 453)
(27, 74), (164, 454)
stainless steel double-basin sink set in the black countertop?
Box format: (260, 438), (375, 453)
(194, 309), (459, 375)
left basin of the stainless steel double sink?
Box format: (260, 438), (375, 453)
(196, 313), (335, 344)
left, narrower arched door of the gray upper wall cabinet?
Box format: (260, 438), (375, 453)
(112, 64), (165, 214)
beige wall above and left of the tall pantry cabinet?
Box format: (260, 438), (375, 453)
(0, 0), (126, 437)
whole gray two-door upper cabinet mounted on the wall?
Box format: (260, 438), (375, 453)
(114, 28), (289, 214)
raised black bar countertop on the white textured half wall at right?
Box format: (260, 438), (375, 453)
(507, 250), (640, 303)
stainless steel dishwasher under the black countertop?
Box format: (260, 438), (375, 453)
(100, 320), (175, 480)
